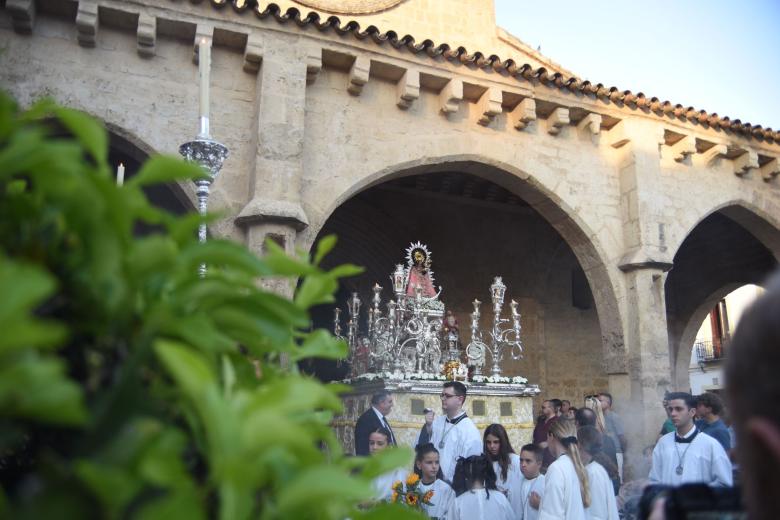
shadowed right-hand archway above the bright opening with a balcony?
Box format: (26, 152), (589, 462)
(665, 203), (780, 390)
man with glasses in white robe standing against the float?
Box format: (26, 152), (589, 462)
(415, 381), (482, 482)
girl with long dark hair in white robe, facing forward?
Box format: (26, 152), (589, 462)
(482, 424), (523, 519)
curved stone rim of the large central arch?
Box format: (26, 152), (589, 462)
(299, 154), (628, 374)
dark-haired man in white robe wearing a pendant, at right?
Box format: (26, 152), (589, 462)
(650, 392), (732, 486)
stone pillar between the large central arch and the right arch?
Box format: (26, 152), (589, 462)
(609, 120), (672, 477)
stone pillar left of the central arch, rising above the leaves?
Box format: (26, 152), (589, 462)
(236, 33), (308, 296)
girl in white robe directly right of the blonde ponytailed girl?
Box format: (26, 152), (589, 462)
(577, 426), (619, 520)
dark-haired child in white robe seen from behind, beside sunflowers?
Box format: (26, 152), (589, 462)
(447, 455), (514, 520)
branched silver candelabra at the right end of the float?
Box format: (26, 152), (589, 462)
(466, 276), (523, 376)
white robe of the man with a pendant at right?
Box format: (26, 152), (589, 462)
(650, 426), (732, 486)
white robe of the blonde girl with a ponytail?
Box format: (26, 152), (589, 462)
(539, 454), (586, 520)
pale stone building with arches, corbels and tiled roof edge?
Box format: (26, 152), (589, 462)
(0, 0), (780, 458)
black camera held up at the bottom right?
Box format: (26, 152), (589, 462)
(637, 484), (747, 520)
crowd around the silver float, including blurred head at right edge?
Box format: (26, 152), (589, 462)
(355, 274), (780, 520)
